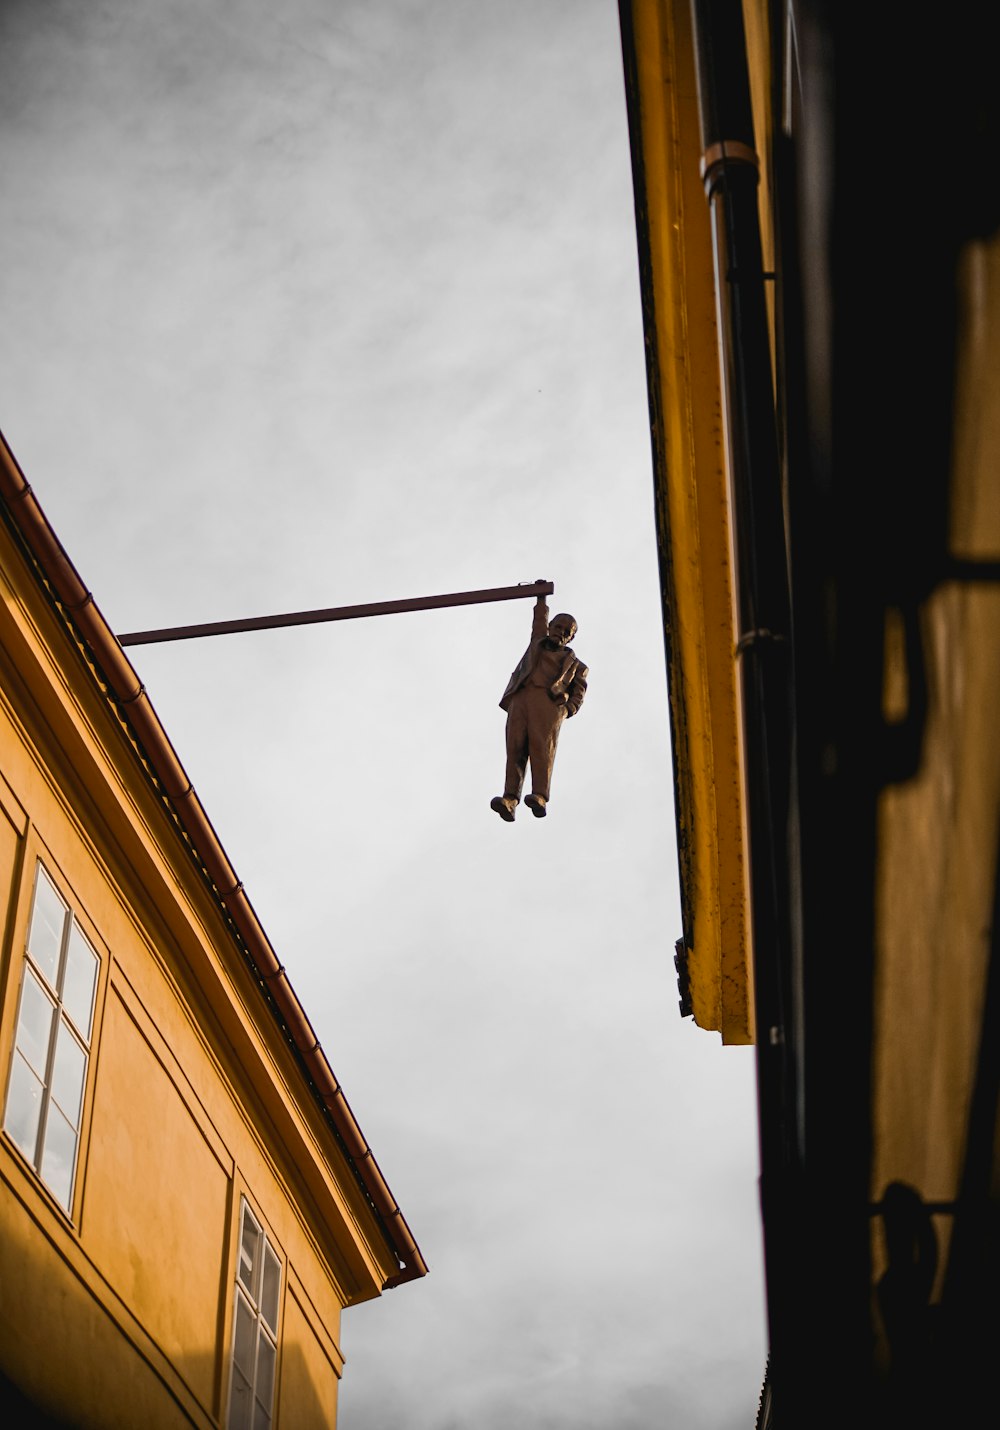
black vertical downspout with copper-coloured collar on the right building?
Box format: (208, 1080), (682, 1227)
(691, 0), (800, 1407)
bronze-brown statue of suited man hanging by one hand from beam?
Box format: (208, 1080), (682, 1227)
(489, 596), (588, 824)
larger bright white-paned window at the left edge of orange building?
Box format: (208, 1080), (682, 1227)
(3, 864), (99, 1213)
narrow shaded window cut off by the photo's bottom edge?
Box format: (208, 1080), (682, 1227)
(227, 1198), (282, 1430)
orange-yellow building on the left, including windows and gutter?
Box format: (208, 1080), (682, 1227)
(0, 428), (426, 1430)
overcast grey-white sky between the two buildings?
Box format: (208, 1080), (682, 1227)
(0, 0), (765, 1430)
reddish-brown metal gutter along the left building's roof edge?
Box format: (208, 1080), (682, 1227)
(0, 433), (428, 1290)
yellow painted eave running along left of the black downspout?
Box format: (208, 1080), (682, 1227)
(631, 0), (753, 1044)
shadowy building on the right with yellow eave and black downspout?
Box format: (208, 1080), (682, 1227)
(619, 0), (1000, 1430)
